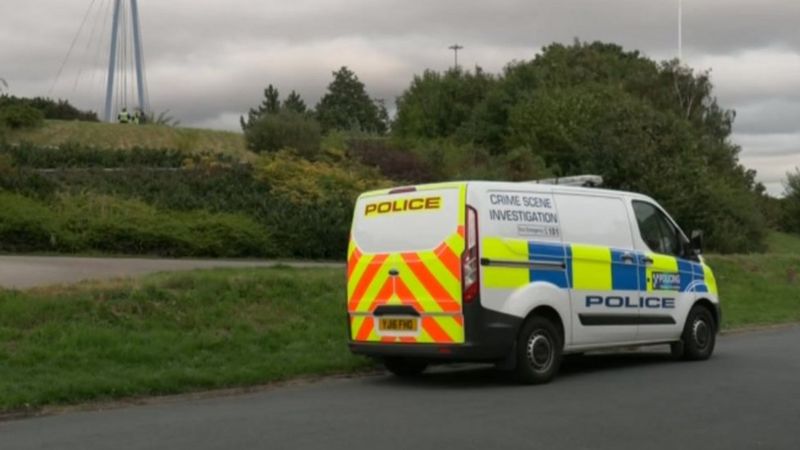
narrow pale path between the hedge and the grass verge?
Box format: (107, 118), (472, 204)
(0, 256), (343, 289)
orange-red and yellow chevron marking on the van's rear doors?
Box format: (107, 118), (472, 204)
(347, 187), (465, 344)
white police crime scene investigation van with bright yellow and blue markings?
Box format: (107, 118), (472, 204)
(347, 181), (721, 383)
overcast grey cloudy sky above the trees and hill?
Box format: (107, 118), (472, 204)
(0, 0), (800, 194)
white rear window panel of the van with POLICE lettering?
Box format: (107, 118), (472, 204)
(352, 187), (462, 253)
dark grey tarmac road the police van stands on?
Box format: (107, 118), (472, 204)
(0, 327), (800, 450)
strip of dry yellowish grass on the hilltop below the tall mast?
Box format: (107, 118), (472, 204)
(8, 120), (249, 156)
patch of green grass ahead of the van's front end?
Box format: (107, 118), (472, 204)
(708, 253), (800, 329)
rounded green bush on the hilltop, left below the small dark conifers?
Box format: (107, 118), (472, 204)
(245, 111), (322, 159)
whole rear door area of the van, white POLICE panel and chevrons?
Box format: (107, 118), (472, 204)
(347, 183), (466, 344)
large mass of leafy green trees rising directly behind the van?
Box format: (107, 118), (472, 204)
(392, 41), (766, 252)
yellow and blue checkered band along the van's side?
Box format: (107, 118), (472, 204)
(482, 237), (716, 294)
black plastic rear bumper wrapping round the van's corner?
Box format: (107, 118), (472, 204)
(348, 304), (522, 362)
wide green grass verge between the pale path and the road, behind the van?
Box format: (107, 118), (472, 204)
(0, 268), (370, 411)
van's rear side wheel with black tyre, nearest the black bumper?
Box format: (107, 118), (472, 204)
(516, 316), (564, 384)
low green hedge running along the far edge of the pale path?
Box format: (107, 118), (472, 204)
(0, 193), (276, 257)
